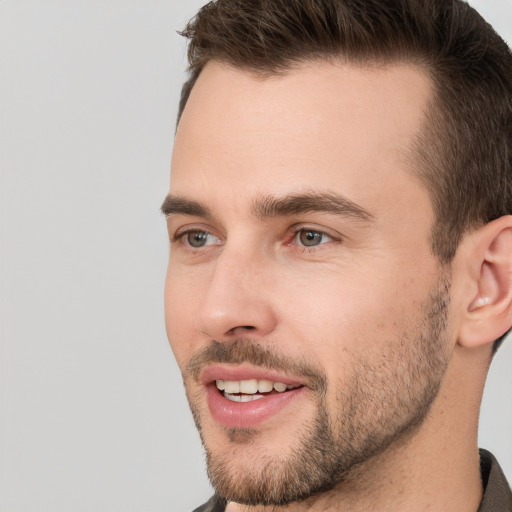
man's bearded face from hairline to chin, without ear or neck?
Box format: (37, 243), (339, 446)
(164, 63), (449, 504)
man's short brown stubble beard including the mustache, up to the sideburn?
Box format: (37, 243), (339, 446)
(184, 279), (449, 506)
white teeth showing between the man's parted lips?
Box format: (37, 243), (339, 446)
(215, 379), (303, 402)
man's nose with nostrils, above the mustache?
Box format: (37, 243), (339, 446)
(197, 248), (277, 341)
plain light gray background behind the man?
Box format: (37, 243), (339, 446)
(0, 0), (512, 512)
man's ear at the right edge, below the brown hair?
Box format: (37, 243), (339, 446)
(458, 215), (512, 348)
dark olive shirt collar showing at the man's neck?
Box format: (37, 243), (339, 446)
(194, 450), (512, 512)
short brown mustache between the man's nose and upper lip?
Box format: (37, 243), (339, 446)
(183, 338), (327, 392)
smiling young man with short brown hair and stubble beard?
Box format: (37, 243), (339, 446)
(162, 0), (512, 512)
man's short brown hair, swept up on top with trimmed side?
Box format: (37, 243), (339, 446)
(178, 0), (512, 348)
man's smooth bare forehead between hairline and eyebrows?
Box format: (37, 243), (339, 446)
(171, 62), (431, 220)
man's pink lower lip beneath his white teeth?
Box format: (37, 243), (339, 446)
(207, 384), (306, 428)
